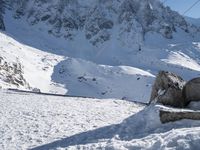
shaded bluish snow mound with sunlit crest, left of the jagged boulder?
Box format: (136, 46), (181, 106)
(52, 58), (154, 102)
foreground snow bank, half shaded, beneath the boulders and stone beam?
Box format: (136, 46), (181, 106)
(67, 105), (200, 150)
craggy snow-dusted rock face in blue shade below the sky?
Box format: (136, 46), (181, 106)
(4, 0), (195, 45)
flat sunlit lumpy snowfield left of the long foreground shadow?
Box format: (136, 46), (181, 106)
(0, 91), (143, 150)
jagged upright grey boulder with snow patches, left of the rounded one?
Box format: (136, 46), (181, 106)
(150, 71), (186, 107)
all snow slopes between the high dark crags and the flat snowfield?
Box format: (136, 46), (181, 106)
(0, 11), (200, 102)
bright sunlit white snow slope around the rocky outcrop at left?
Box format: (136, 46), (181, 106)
(0, 33), (66, 92)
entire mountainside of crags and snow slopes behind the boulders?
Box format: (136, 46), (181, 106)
(0, 0), (200, 102)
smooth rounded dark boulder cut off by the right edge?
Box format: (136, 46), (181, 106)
(183, 78), (200, 104)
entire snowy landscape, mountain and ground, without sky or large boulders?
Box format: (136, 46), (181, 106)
(0, 0), (200, 150)
